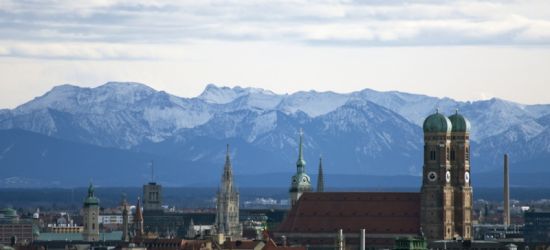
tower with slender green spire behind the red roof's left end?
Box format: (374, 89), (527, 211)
(289, 130), (311, 206)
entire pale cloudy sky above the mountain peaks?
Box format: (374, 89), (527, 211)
(0, 0), (550, 108)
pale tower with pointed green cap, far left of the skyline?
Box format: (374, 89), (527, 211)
(82, 183), (99, 241)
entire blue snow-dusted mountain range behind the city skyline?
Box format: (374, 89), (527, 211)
(0, 82), (550, 187)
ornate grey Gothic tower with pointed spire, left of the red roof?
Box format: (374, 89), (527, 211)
(214, 145), (242, 238)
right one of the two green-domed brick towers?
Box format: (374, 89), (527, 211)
(449, 110), (472, 240)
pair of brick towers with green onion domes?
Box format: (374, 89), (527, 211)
(420, 111), (472, 240)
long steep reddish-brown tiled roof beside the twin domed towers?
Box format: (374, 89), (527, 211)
(277, 192), (420, 234)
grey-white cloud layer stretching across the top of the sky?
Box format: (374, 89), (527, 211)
(0, 0), (550, 59)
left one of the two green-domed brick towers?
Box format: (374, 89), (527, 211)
(420, 111), (455, 240)
